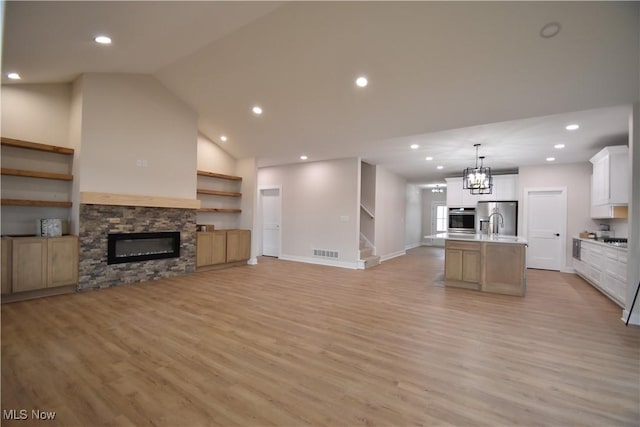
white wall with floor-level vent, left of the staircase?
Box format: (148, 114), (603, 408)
(258, 158), (360, 268)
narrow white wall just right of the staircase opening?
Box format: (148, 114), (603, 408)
(375, 166), (407, 261)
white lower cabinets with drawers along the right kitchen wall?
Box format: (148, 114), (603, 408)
(573, 240), (628, 306)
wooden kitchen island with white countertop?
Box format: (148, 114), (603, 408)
(426, 233), (527, 296)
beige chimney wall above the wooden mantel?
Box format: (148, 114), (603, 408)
(76, 73), (197, 199)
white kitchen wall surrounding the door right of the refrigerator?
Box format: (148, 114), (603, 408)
(518, 162), (599, 270)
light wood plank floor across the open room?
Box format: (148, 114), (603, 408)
(1, 247), (640, 426)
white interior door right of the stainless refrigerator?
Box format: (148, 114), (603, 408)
(525, 189), (567, 271)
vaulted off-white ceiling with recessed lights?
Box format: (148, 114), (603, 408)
(3, 1), (640, 186)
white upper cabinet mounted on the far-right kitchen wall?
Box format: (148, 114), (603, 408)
(590, 145), (629, 206)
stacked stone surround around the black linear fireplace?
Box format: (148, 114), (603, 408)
(78, 203), (196, 290)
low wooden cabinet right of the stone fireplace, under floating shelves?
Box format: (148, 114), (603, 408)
(196, 229), (251, 267)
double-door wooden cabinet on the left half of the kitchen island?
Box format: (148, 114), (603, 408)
(444, 240), (480, 289)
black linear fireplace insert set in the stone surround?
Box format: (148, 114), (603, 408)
(107, 231), (180, 264)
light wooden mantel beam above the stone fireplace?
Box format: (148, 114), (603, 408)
(80, 191), (200, 209)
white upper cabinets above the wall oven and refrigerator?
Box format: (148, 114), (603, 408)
(446, 174), (518, 207)
